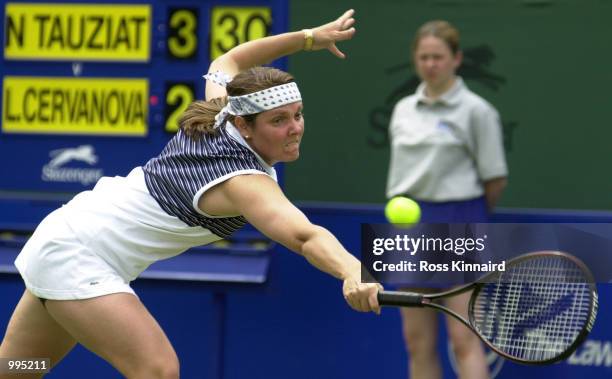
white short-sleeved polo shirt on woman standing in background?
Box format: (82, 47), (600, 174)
(387, 77), (508, 202)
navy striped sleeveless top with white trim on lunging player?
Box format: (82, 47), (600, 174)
(143, 123), (276, 238)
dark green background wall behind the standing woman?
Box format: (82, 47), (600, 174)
(285, 0), (612, 210)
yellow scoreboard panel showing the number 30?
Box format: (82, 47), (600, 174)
(210, 7), (272, 61)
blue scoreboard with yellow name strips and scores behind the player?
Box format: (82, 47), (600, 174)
(0, 0), (288, 214)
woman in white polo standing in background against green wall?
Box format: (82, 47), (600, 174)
(387, 21), (508, 379)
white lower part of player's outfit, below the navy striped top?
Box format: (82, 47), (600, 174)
(15, 168), (220, 300)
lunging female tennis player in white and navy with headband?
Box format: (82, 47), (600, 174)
(0, 10), (379, 379)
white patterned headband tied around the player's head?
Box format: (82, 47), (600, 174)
(204, 71), (302, 129)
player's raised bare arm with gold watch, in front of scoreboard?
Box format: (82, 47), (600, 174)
(206, 9), (355, 100)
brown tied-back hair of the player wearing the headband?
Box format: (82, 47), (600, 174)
(179, 67), (294, 139)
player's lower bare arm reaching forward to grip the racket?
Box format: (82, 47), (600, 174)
(198, 175), (381, 313)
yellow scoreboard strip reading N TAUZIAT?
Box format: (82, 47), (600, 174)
(4, 3), (151, 62)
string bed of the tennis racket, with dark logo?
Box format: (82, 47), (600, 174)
(472, 256), (592, 361)
